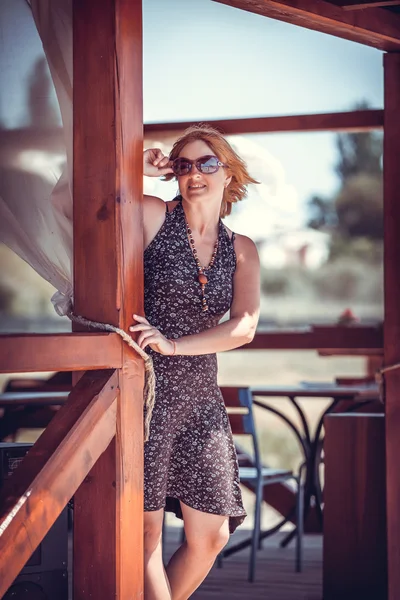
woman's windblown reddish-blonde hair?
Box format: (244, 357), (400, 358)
(165, 123), (259, 218)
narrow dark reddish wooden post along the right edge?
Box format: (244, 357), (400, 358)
(383, 53), (400, 600)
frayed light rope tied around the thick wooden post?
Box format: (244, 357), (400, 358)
(66, 310), (156, 442)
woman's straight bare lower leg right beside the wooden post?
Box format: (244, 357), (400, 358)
(144, 509), (171, 600)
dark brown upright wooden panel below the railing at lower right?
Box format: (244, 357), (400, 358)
(323, 414), (388, 600)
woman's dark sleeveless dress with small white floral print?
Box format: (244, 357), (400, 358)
(144, 202), (246, 533)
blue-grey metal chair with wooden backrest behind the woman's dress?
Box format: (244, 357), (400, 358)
(218, 387), (303, 581)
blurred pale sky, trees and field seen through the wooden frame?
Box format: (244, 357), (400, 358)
(0, 0), (383, 522)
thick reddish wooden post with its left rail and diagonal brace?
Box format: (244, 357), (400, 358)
(0, 0), (143, 599)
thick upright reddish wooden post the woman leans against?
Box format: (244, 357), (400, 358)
(73, 0), (143, 600)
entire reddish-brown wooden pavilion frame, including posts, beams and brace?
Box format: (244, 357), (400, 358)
(0, 0), (400, 600)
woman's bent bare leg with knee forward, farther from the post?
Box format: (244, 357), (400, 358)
(166, 502), (229, 600)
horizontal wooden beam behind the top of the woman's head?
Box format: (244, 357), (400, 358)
(144, 110), (383, 139)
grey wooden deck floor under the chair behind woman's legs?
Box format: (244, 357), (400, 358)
(166, 528), (322, 600)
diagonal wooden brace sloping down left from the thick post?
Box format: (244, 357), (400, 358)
(0, 371), (118, 597)
